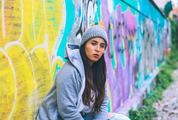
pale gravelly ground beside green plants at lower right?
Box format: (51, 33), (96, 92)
(153, 69), (178, 120)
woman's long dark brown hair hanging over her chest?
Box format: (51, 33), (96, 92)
(80, 44), (106, 112)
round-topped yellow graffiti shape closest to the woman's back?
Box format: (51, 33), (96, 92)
(30, 47), (53, 110)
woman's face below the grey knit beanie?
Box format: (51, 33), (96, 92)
(85, 37), (106, 64)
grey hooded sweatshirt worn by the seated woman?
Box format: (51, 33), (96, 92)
(36, 44), (108, 120)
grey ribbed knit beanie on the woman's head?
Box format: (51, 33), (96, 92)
(80, 25), (108, 46)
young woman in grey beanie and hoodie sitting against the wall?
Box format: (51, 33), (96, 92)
(37, 25), (108, 120)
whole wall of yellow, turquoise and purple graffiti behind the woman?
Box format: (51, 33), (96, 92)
(0, 0), (171, 120)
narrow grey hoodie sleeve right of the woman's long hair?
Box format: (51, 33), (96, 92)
(94, 85), (108, 120)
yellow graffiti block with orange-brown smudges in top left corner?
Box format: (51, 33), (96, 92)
(0, 0), (22, 47)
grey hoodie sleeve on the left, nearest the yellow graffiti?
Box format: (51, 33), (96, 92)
(56, 64), (83, 120)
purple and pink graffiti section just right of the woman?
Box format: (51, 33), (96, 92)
(101, 0), (138, 111)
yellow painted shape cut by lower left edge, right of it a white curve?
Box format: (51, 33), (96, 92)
(0, 49), (16, 119)
